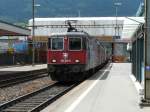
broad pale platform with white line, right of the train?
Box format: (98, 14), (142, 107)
(41, 63), (150, 112)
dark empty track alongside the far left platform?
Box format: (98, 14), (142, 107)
(0, 70), (47, 88)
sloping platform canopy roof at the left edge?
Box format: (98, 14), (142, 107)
(0, 20), (31, 36)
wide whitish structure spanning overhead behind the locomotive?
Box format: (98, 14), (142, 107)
(29, 17), (144, 42)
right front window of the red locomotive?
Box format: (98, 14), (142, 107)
(69, 38), (82, 50)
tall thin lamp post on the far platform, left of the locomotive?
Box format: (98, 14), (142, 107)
(32, 0), (40, 66)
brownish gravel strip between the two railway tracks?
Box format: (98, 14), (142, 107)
(0, 76), (54, 104)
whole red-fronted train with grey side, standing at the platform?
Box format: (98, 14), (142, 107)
(47, 25), (108, 81)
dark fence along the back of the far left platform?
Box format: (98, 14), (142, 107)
(0, 50), (47, 66)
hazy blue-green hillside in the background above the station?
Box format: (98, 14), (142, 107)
(0, 0), (142, 22)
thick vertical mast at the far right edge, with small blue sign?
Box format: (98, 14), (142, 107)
(144, 0), (150, 102)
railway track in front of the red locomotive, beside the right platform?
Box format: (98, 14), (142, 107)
(0, 83), (77, 112)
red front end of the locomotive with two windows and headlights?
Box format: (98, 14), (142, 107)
(47, 32), (87, 81)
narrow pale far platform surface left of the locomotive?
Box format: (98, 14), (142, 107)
(0, 64), (47, 72)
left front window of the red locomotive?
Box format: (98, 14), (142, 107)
(51, 38), (64, 50)
